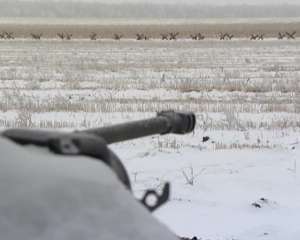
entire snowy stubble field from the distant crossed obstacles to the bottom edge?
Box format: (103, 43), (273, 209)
(0, 40), (300, 240)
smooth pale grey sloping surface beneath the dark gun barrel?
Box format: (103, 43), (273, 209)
(0, 137), (177, 240)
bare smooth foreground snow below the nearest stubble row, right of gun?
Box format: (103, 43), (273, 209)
(116, 143), (300, 240)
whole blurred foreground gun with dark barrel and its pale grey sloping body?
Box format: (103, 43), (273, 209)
(0, 111), (195, 240)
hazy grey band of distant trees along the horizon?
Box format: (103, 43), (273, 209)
(0, 0), (300, 19)
